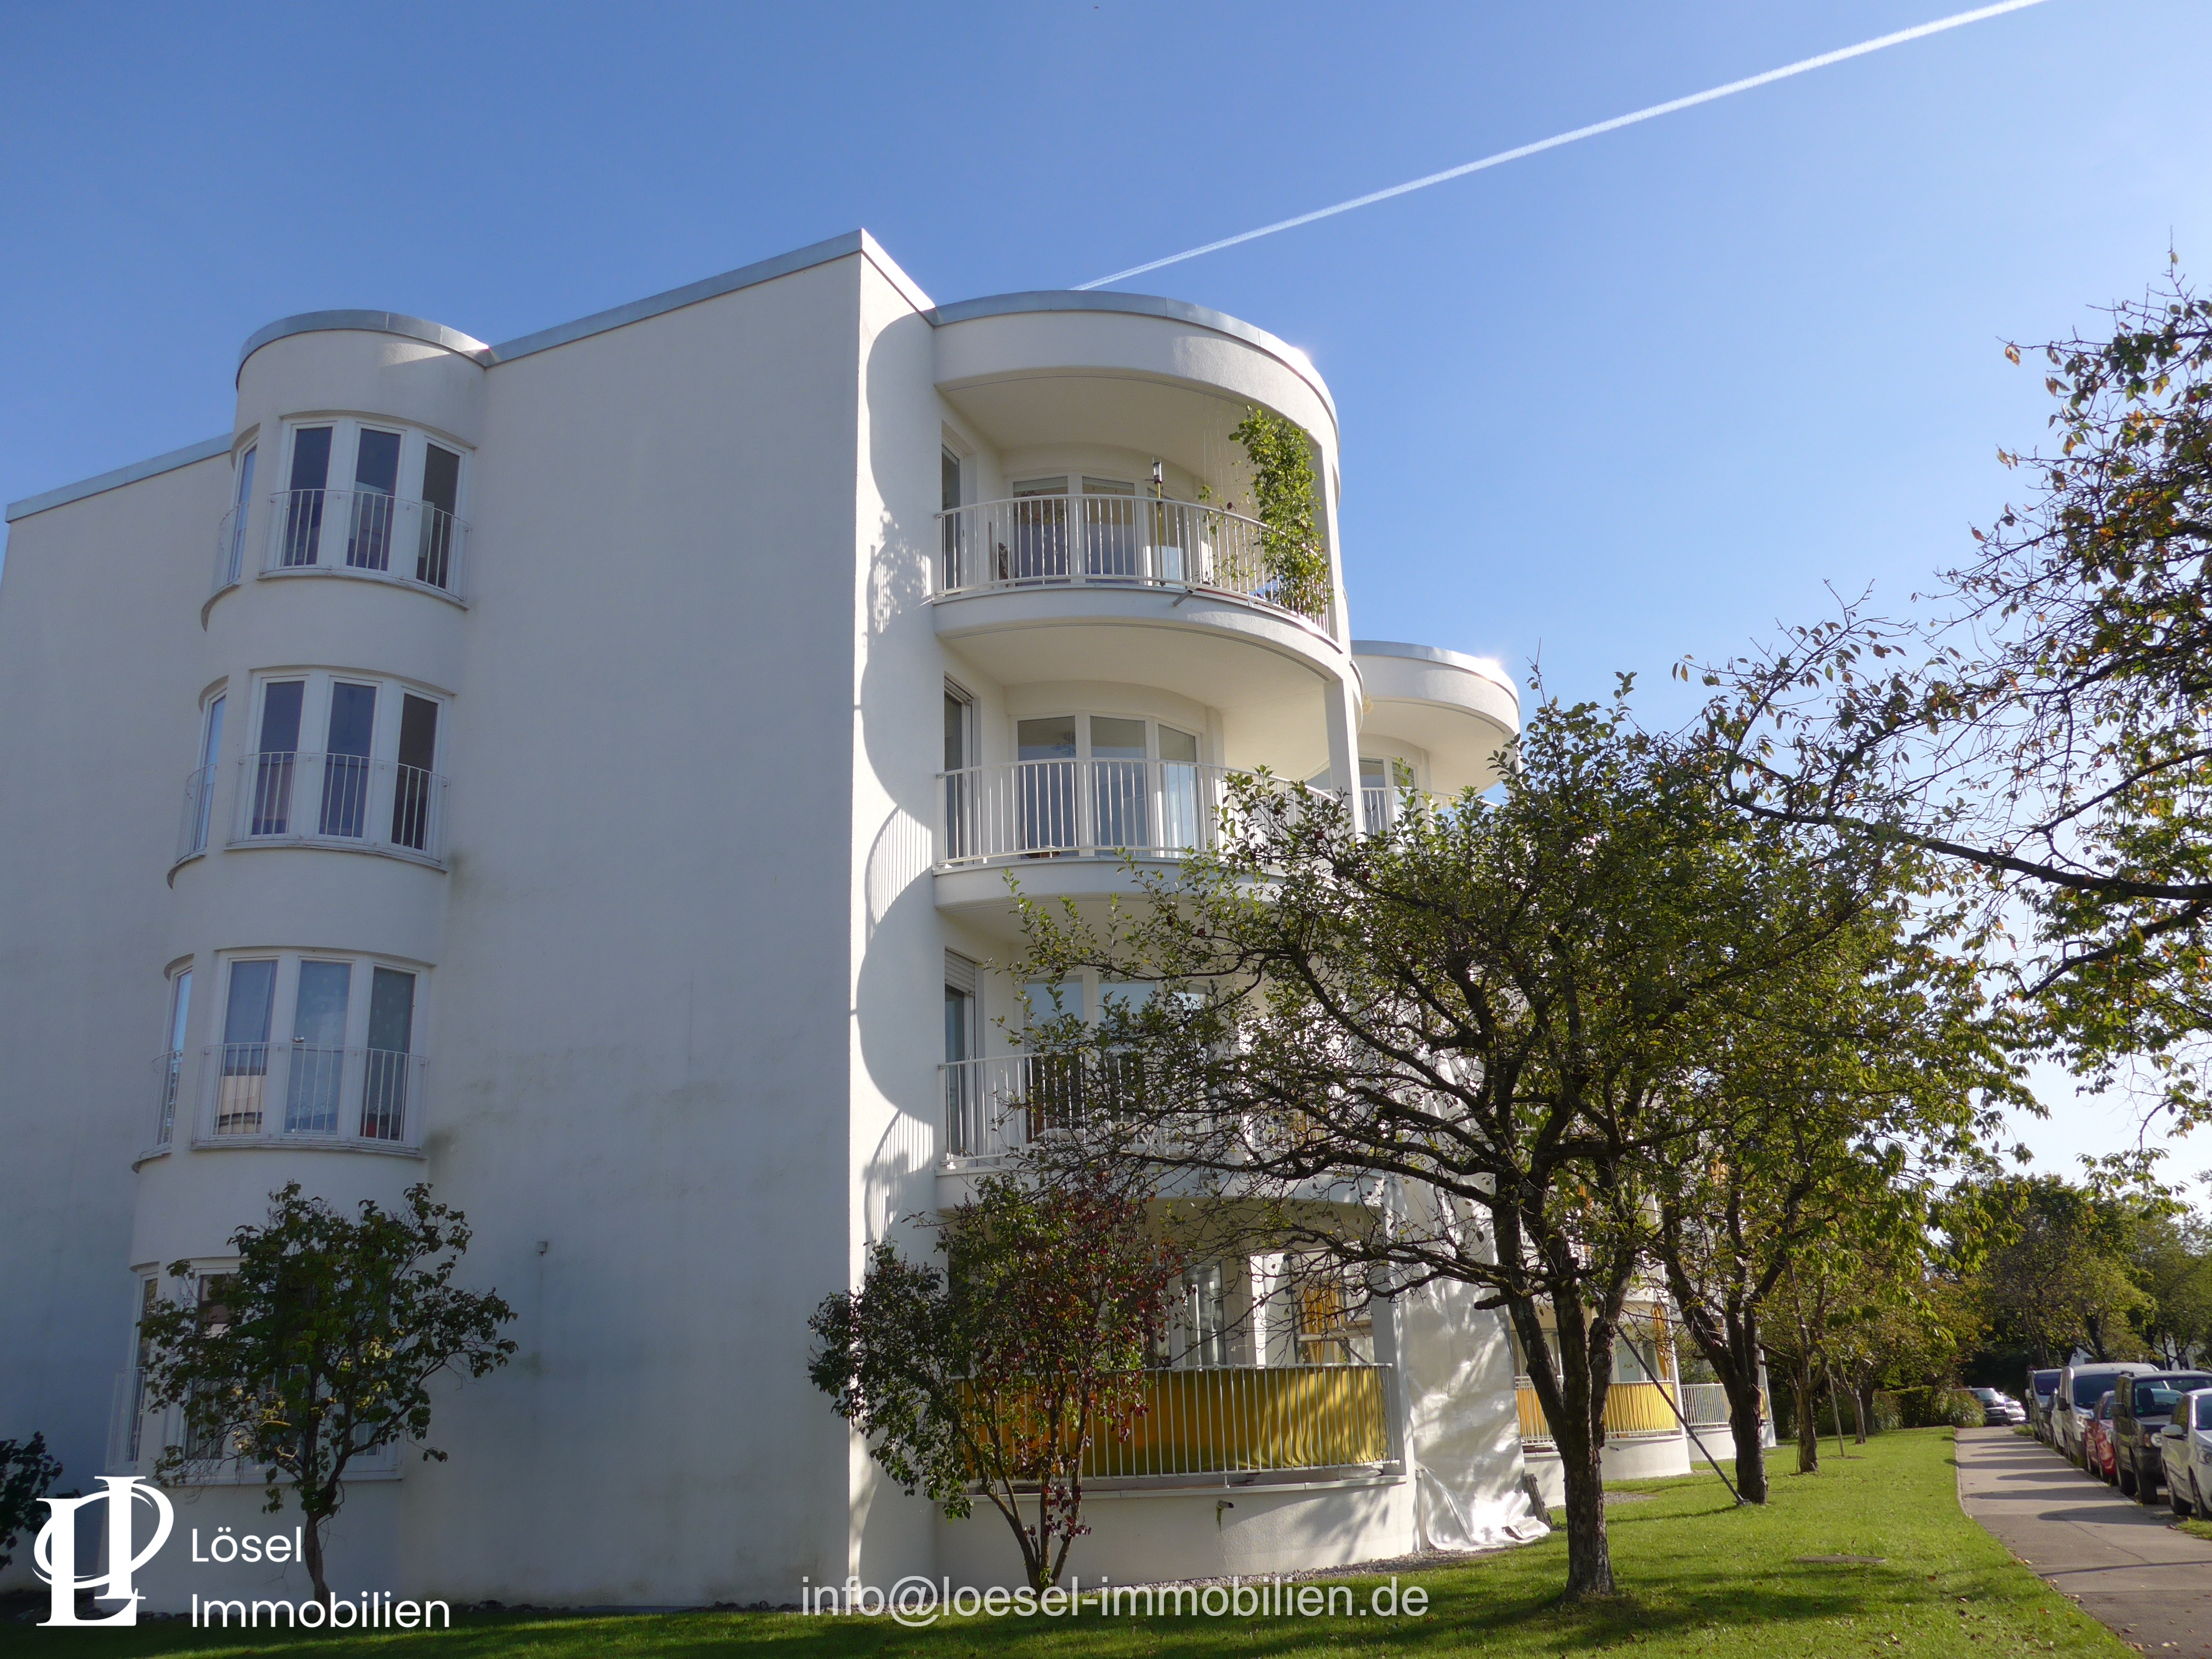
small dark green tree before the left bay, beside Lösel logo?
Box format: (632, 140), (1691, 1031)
(139, 1181), (515, 1606)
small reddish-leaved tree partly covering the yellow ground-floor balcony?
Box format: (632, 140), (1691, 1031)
(807, 1172), (1181, 1590)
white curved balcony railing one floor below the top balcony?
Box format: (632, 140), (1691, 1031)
(936, 761), (1232, 867)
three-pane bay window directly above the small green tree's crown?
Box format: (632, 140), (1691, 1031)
(210, 953), (422, 1144)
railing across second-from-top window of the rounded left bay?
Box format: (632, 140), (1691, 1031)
(230, 750), (445, 865)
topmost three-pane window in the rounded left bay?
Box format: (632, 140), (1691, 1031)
(270, 420), (465, 595)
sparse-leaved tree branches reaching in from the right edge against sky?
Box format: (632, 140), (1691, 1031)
(1705, 274), (2212, 1141)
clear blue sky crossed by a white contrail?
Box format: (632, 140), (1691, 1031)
(0, 0), (2212, 1164)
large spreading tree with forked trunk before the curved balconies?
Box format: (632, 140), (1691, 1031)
(1018, 679), (1869, 1597)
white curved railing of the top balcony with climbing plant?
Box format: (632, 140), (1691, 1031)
(938, 495), (1329, 630)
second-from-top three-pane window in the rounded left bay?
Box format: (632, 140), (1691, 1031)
(232, 672), (445, 860)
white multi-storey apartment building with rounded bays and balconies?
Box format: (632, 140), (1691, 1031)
(0, 232), (1663, 1608)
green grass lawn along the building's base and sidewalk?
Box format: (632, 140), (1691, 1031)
(0, 1429), (2130, 1659)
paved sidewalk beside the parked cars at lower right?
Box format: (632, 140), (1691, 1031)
(1958, 1429), (2212, 1659)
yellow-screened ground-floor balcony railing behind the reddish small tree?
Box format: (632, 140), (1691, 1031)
(1084, 1365), (1396, 1480)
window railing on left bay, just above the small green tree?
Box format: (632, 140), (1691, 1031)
(204, 1040), (429, 1146)
